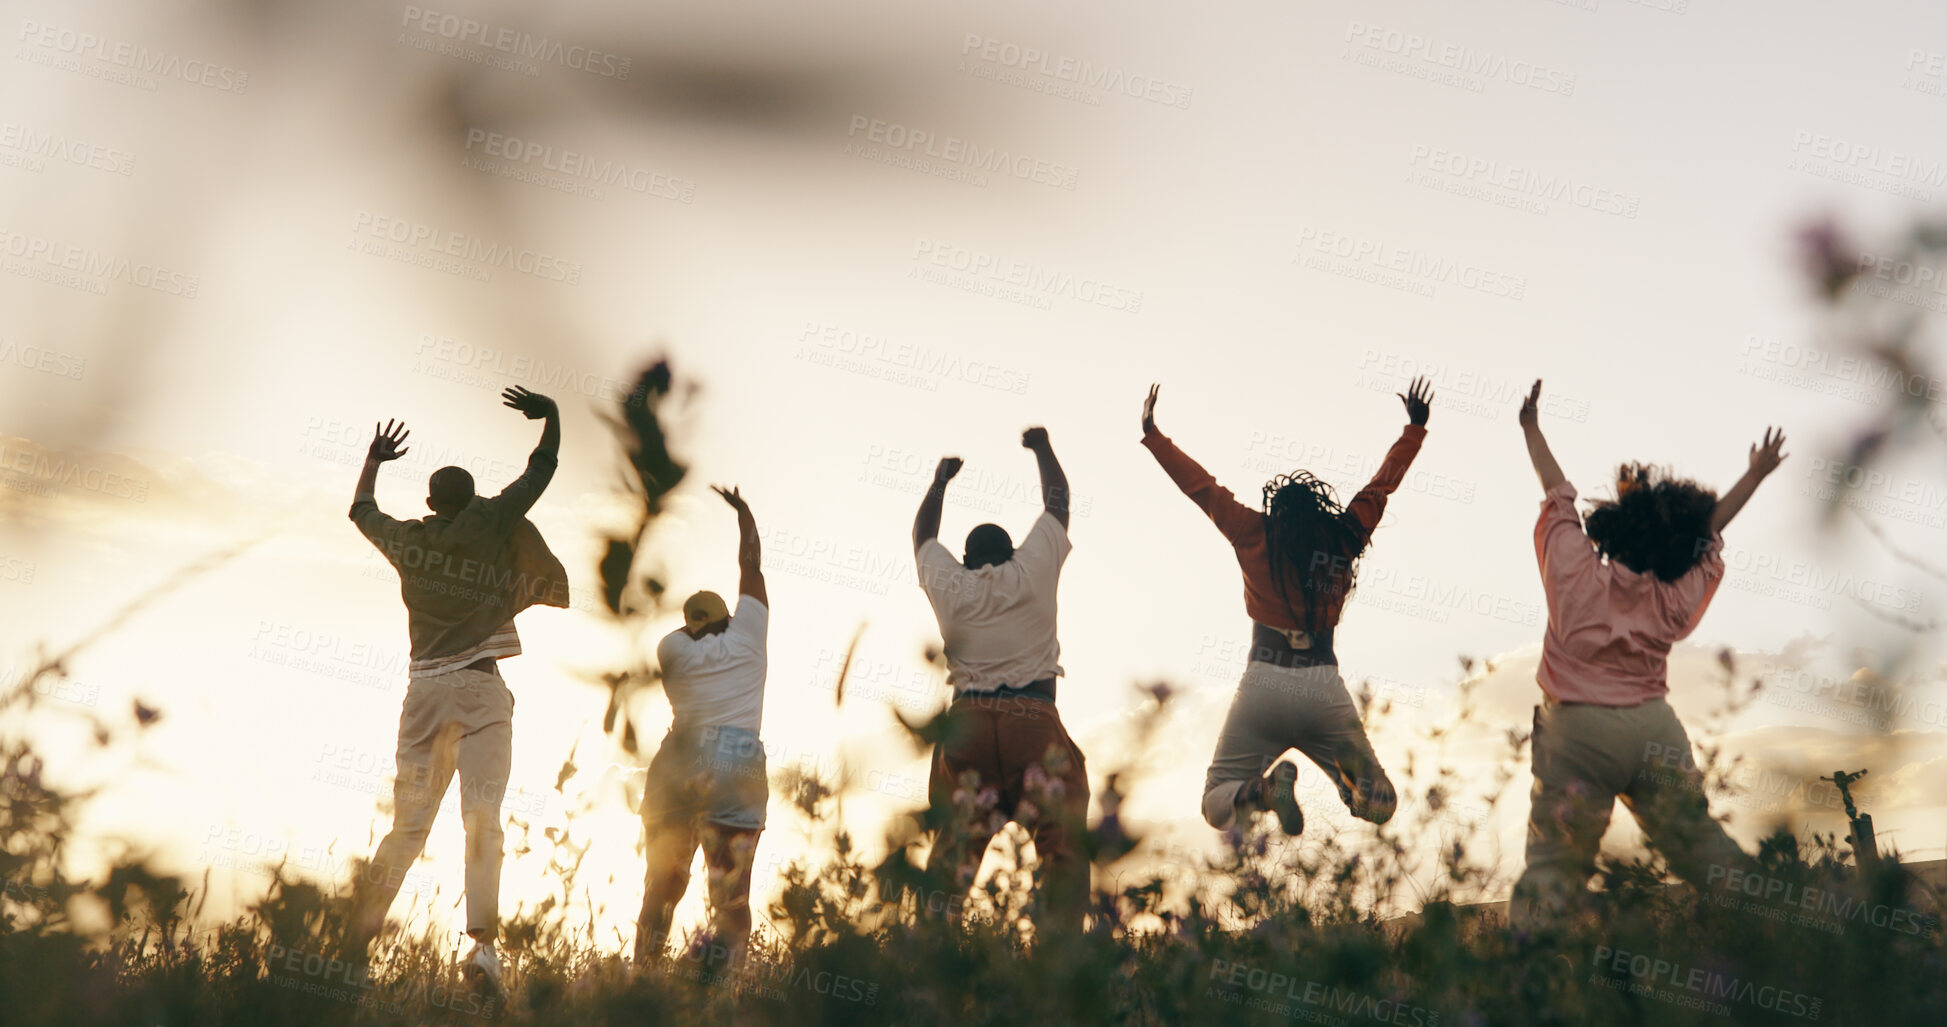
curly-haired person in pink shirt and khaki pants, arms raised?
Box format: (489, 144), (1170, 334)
(1507, 380), (1785, 932)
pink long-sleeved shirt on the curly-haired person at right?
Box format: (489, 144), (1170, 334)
(1534, 481), (1723, 705)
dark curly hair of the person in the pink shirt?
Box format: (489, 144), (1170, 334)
(1585, 464), (1717, 581)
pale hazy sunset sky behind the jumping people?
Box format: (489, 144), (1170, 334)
(0, 0), (1947, 937)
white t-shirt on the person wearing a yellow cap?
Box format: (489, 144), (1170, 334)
(656, 596), (771, 735)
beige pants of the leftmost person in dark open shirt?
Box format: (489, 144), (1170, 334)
(354, 670), (514, 941)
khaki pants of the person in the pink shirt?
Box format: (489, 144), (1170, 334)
(1507, 700), (1746, 930)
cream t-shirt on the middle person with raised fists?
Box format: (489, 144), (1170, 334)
(917, 513), (1073, 694)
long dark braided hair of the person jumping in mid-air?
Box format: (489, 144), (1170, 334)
(1264, 472), (1367, 635)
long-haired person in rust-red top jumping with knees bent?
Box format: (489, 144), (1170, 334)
(1143, 378), (1433, 834)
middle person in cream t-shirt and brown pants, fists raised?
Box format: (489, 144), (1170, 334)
(913, 429), (1088, 928)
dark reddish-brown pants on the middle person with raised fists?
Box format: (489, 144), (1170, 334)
(927, 694), (1088, 928)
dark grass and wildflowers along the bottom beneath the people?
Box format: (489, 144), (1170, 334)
(0, 646), (1947, 1027)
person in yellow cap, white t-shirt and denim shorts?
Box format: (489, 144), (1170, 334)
(635, 487), (771, 965)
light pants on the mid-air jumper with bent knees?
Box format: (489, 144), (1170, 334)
(1203, 661), (1392, 830)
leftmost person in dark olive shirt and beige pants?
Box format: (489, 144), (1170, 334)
(347, 386), (569, 988)
